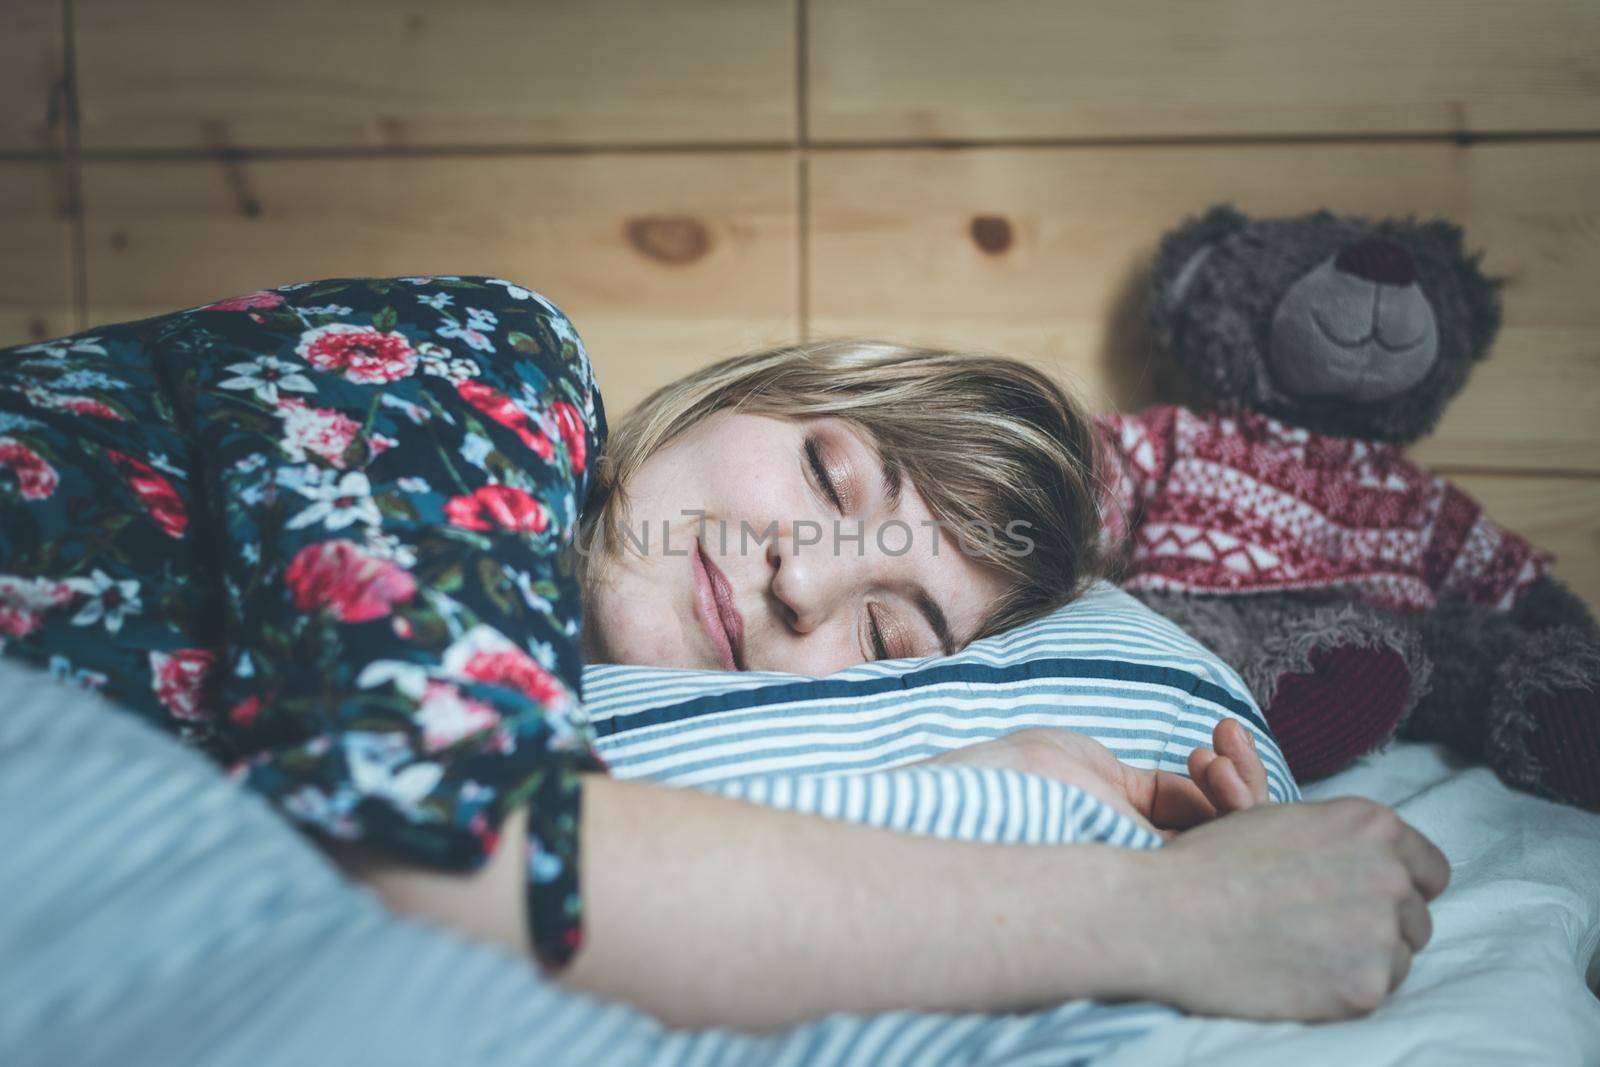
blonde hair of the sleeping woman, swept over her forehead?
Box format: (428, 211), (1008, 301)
(579, 341), (1102, 637)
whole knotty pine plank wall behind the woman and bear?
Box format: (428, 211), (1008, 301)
(0, 0), (1600, 603)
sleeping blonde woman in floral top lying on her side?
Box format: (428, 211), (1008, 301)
(0, 277), (1448, 1029)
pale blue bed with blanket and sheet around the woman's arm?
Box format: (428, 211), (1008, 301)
(0, 652), (1600, 1067)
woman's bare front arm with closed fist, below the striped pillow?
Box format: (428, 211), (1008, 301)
(334, 776), (1450, 1030)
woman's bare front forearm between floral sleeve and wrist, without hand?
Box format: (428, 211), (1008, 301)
(562, 777), (1134, 1029)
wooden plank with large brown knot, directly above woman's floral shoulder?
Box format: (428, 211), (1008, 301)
(85, 152), (798, 413)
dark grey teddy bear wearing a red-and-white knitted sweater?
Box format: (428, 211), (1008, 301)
(1098, 205), (1600, 809)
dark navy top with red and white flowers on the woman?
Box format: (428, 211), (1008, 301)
(0, 277), (606, 965)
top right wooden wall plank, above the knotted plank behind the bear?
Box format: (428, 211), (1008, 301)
(808, 0), (1600, 141)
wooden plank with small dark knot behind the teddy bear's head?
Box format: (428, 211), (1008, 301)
(808, 142), (1600, 472)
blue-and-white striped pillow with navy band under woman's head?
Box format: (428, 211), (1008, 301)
(584, 582), (1299, 801)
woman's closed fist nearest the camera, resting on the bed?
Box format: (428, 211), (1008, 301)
(1126, 797), (1450, 1021)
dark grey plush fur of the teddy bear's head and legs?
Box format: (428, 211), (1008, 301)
(1144, 205), (1600, 803)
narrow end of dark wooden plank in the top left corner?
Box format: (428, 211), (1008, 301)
(0, 0), (64, 152)
